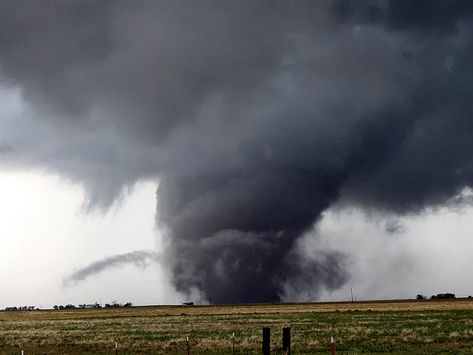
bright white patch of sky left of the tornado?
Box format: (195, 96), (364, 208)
(0, 171), (181, 308)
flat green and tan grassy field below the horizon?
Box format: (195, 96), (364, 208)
(0, 299), (473, 355)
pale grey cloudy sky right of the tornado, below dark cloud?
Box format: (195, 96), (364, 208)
(301, 207), (473, 300)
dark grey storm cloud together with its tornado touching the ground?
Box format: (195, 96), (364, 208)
(0, 0), (473, 303)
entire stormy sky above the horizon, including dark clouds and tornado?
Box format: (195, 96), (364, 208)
(0, 0), (473, 306)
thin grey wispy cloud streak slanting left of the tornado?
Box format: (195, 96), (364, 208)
(63, 250), (159, 286)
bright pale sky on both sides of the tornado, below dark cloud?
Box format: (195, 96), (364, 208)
(0, 164), (473, 308)
